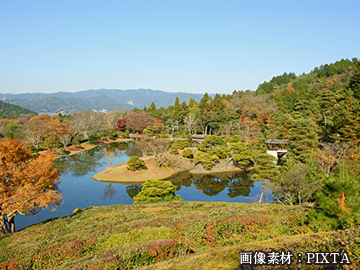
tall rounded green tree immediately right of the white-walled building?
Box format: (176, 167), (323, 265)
(289, 118), (318, 163)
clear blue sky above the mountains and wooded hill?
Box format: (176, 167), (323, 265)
(0, 0), (360, 93)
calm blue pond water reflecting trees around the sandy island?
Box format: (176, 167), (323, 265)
(15, 143), (271, 230)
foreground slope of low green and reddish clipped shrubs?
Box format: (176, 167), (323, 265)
(0, 202), (360, 269)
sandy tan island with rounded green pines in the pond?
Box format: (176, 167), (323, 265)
(93, 135), (265, 184)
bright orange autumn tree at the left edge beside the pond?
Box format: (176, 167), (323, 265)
(0, 139), (62, 234)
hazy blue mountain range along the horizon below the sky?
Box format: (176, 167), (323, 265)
(0, 89), (212, 113)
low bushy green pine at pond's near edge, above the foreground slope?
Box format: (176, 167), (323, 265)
(134, 179), (182, 204)
